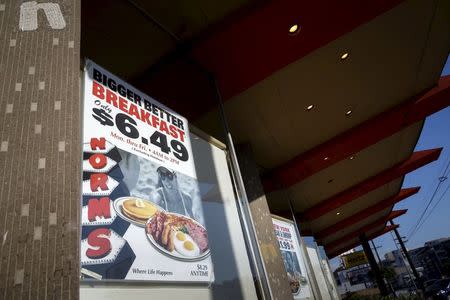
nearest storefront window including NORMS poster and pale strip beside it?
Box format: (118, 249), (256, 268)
(80, 60), (256, 299)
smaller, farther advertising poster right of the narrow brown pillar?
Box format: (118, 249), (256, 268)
(272, 218), (311, 299)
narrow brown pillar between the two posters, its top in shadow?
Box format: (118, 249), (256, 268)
(237, 145), (292, 299)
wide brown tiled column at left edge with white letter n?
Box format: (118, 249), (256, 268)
(0, 0), (81, 299)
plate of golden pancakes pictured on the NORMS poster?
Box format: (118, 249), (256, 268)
(114, 196), (164, 227)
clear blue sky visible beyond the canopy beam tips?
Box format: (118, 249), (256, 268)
(331, 56), (450, 269)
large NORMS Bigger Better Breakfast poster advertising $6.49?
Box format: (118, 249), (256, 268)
(80, 60), (213, 283)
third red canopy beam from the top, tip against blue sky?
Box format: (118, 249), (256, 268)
(301, 149), (442, 221)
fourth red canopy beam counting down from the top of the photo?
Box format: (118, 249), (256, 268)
(314, 187), (420, 240)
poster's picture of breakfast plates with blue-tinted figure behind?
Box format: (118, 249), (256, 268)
(113, 150), (210, 261)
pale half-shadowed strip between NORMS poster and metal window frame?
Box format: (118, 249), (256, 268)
(191, 137), (254, 299)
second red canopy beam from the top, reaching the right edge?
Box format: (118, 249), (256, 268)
(263, 75), (450, 192)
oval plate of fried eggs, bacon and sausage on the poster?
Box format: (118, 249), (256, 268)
(145, 210), (210, 261)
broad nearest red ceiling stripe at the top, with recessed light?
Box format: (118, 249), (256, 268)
(193, 0), (403, 100)
